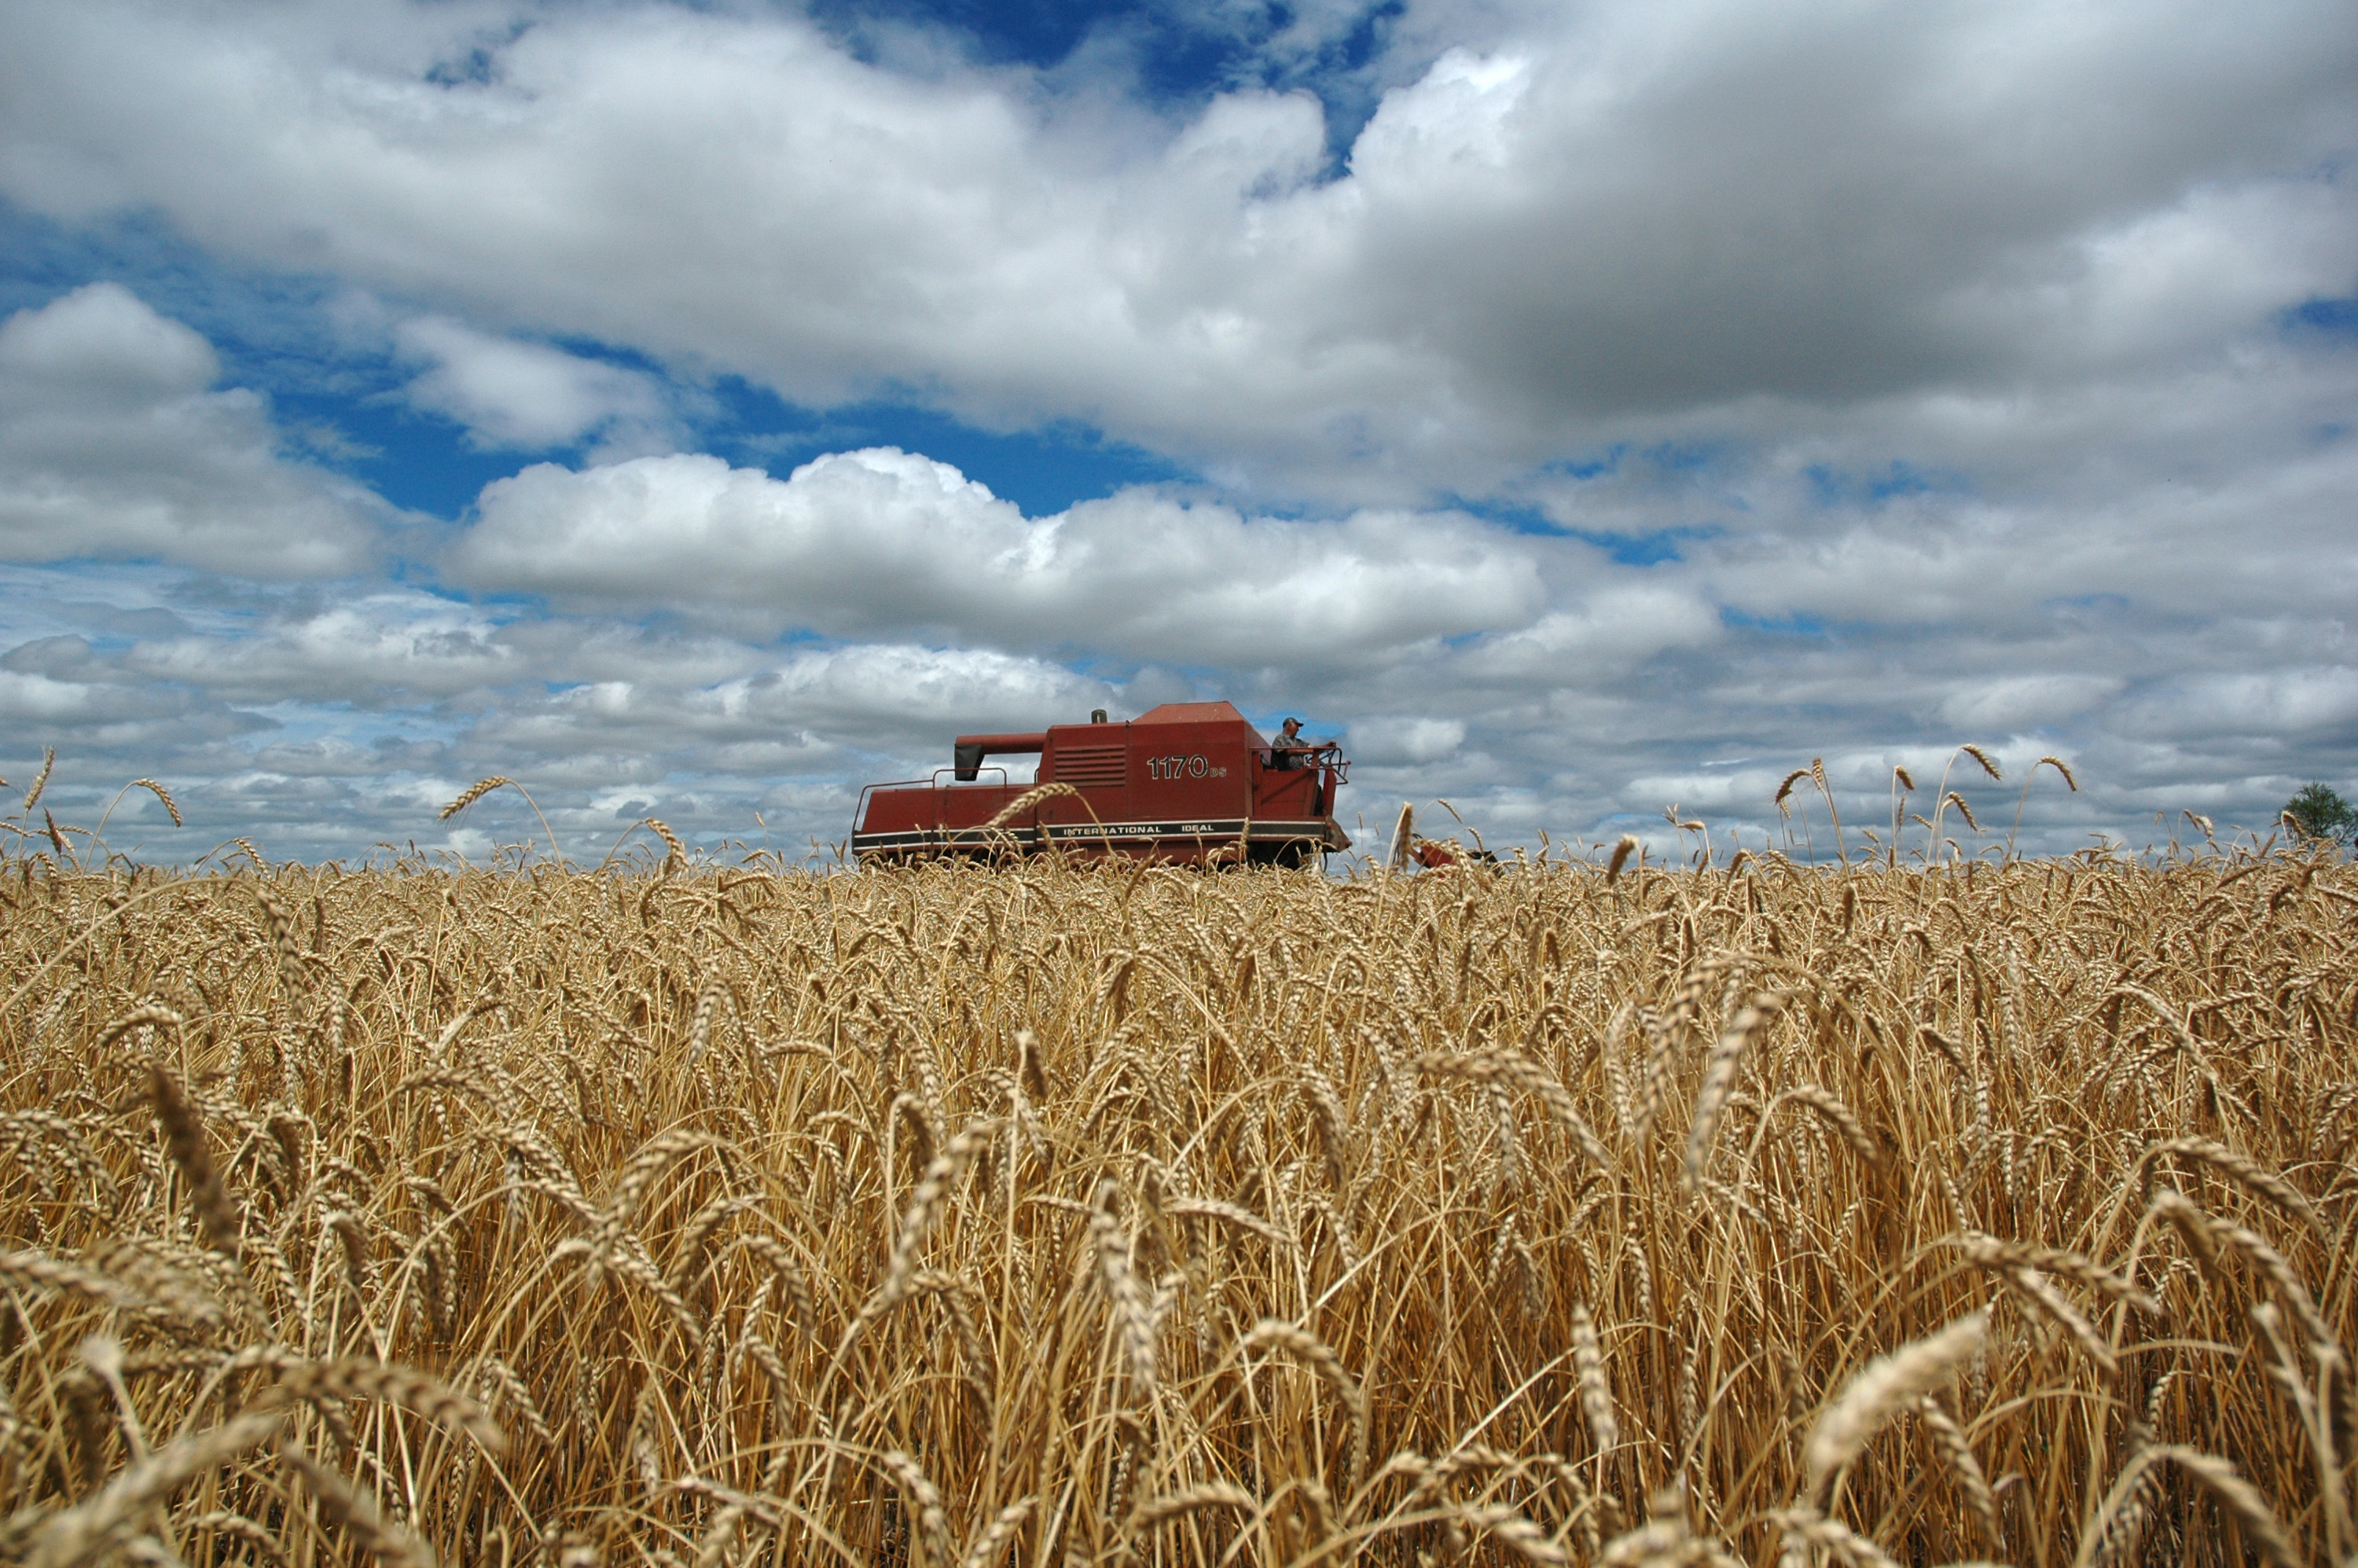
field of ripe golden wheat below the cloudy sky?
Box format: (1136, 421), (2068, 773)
(0, 856), (2358, 1568)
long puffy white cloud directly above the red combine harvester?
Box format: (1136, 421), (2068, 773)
(450, 448), (1542, 667)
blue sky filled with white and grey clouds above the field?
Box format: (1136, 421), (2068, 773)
(0, 0), (2358, 865)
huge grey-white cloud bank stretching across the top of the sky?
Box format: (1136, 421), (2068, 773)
(0, 0), (2358, 498)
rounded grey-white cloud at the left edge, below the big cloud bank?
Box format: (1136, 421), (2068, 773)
(0, 283), (391, 578)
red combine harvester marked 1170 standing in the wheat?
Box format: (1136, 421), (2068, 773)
(851, 703), (1351, 865)
